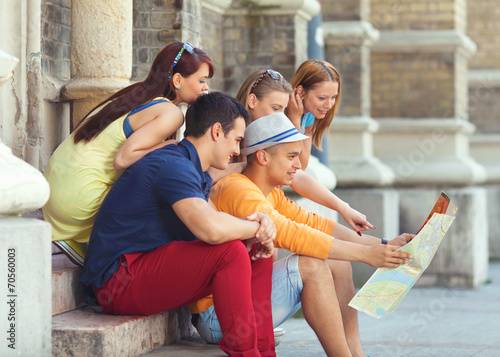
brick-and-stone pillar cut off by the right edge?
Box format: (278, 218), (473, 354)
(467, 0), (500, 258)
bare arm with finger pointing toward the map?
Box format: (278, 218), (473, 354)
(292, 170), (375, 235)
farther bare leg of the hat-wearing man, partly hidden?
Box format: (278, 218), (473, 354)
(327, 260), (365, 357)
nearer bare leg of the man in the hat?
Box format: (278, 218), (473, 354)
(299, 256), (351, 357)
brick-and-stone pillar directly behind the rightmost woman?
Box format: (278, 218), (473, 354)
(323, 16), (394, 187)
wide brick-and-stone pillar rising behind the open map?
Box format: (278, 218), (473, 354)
(370, 0), (488, 286)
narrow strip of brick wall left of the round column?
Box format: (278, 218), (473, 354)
(41, 0), (71, 80)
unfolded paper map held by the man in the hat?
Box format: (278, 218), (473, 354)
(349, 193), (457, 318)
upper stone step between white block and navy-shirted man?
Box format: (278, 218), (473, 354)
(52, 254), (84, 315)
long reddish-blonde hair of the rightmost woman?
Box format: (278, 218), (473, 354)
(290, 59), (342, 150)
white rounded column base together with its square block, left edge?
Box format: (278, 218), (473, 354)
(0, 50), (52, 357)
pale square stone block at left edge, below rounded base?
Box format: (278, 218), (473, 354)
(0, 217), (52, 357)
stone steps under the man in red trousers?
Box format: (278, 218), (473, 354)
(52, 254), (198, 357)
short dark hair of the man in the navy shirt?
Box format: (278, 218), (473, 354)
(184, 92), (250, 138)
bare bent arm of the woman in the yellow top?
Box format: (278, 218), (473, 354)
(113, 103), (184, 170)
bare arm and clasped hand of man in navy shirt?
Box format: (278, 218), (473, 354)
(172, 197), (276, 245)
